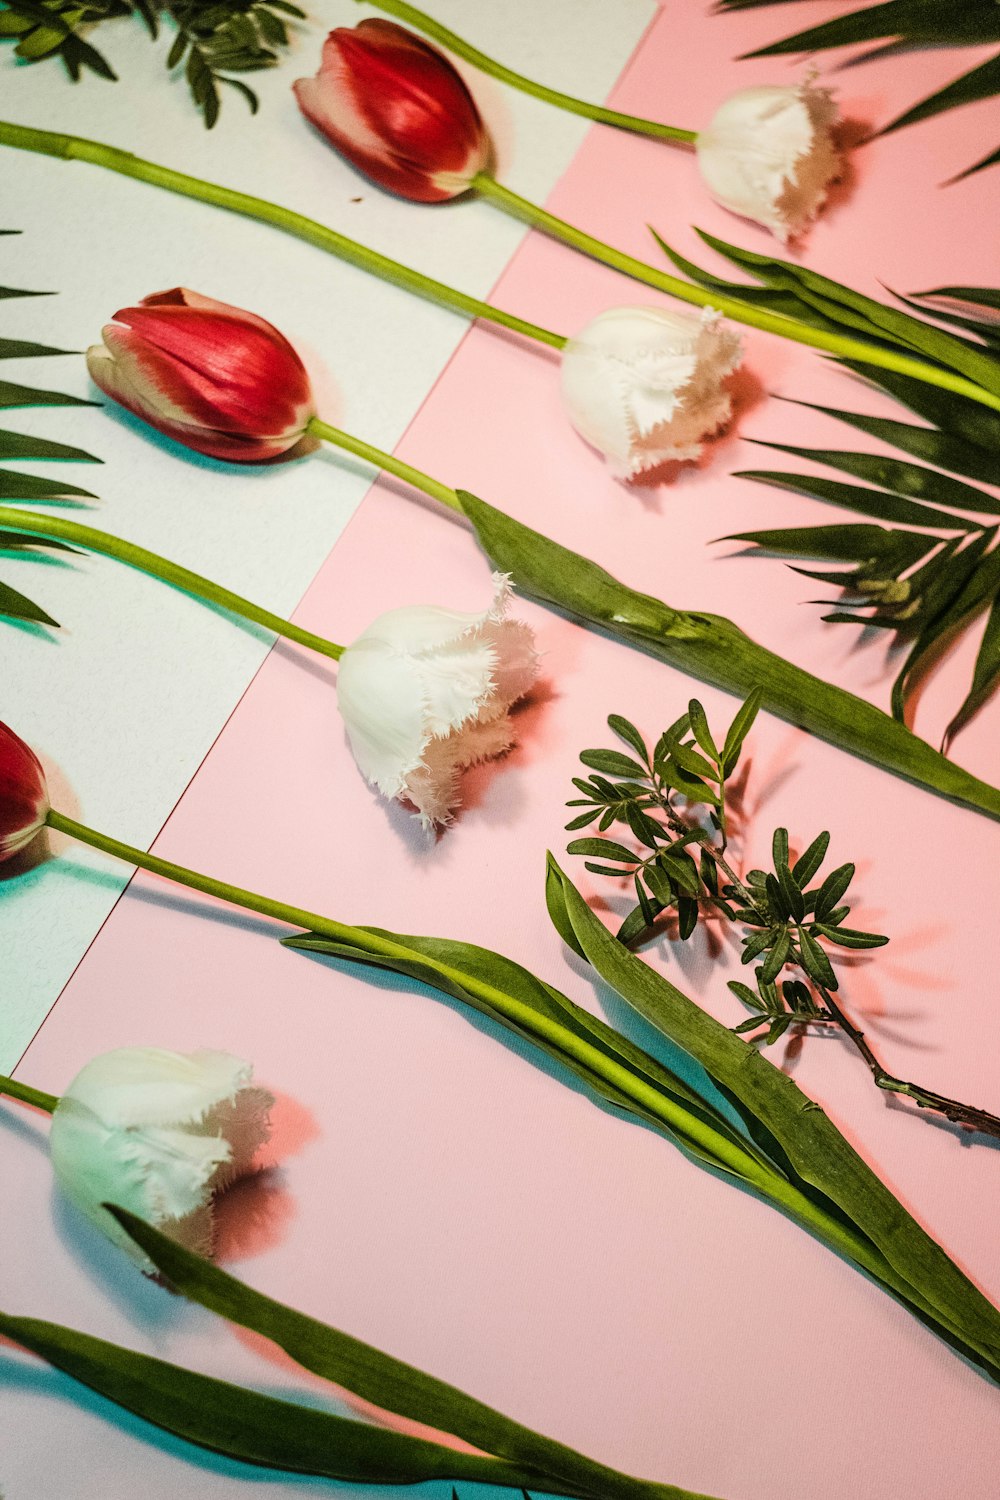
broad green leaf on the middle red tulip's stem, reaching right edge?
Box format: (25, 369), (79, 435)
(459, 491), (1000, 818)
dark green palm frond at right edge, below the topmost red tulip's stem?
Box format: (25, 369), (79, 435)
(726, 287), (1000, 746)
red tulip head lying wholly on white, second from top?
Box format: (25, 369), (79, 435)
(87, 287), (315, 464)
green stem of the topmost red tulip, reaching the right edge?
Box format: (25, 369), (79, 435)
(472, 173), (1000, 411)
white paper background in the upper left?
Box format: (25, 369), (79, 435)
(0, 0), (655, 1071)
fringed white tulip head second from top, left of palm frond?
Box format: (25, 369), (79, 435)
(562, 308), (742, 479)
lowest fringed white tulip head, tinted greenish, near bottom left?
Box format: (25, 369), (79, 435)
(49, 1047), (274, 1272)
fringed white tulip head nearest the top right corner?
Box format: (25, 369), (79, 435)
(694, 81), (840, 245)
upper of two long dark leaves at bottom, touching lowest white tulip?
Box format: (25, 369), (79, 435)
(106, 1205), (704, 1500)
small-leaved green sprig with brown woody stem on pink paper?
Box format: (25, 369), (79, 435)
(567, 692), (1000, 1137)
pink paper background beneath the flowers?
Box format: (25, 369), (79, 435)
(0, 3), (1000, 1500)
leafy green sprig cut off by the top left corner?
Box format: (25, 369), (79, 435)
(0, 0), (306, 129)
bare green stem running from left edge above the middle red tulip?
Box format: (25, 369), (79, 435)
(0, 122), (567, 350)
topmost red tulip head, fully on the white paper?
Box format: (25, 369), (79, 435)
(294, 21), (492, 203)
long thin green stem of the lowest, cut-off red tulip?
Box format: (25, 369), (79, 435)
(46, 809), (912, 1299)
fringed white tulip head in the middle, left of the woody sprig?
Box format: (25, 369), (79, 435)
(337, 573), (538, 828)
